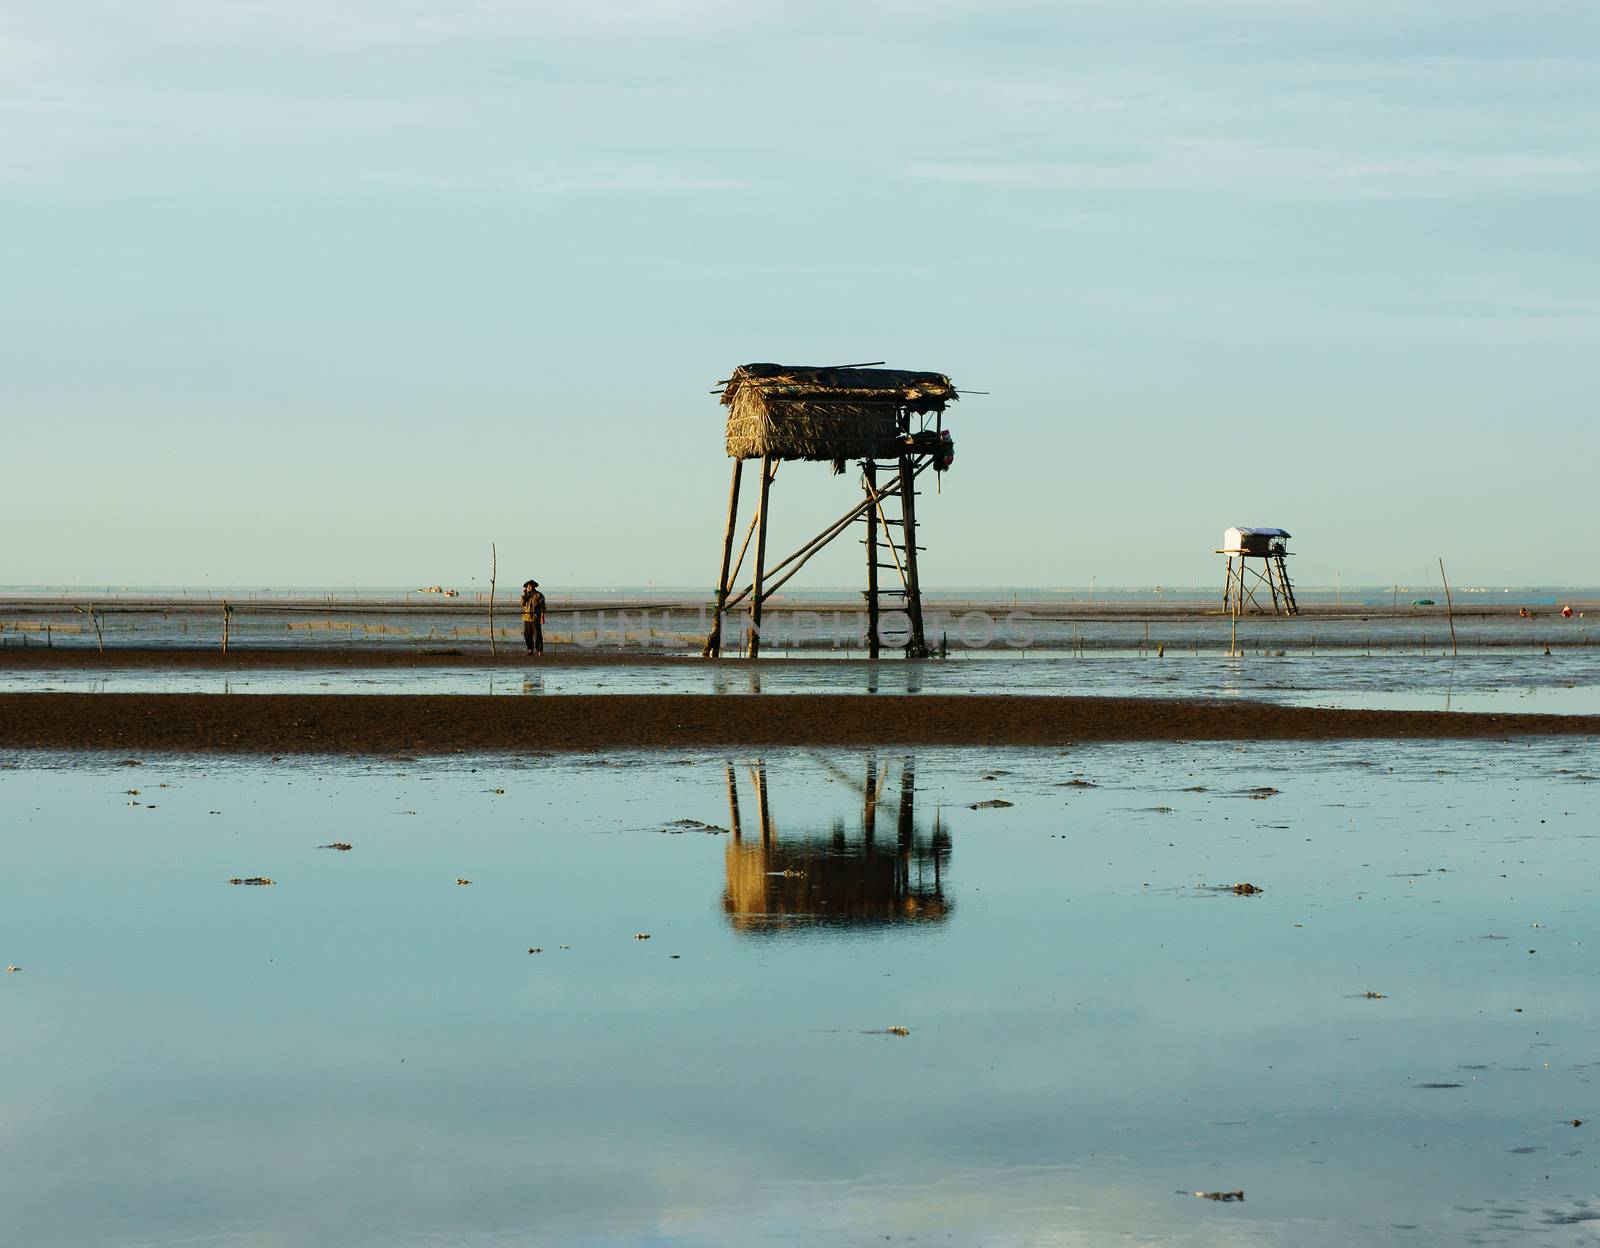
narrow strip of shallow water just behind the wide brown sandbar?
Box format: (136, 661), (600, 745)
(0, 648), (1600, 715)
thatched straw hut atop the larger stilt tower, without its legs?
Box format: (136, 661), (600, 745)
(720, 363), (958, 459)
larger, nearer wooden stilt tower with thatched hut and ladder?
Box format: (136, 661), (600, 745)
(702, 363), (958, 659)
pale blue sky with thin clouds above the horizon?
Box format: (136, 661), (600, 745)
(0, 0), (1600, 589)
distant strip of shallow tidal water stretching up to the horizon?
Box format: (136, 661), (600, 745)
(0, 590), (1600, 658)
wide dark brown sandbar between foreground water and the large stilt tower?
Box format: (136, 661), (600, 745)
(0, 693), (1600, 755)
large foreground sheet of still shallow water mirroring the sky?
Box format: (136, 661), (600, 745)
(0, 739), (1600, 1248)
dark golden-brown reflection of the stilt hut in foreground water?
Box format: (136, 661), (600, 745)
(722, 757), (954, 931)
